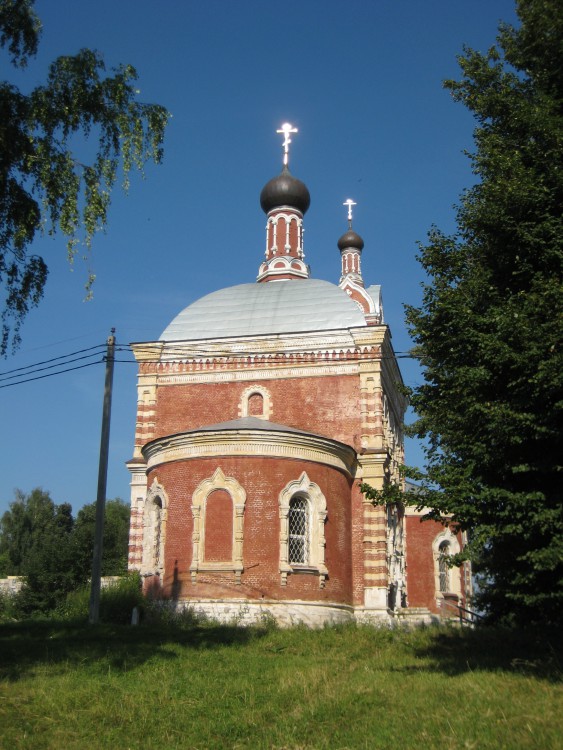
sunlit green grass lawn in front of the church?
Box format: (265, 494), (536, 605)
(0, 622), (563, 750)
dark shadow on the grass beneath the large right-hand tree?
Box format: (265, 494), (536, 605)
(399, 627), (563, 682)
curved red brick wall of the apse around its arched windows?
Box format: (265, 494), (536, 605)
(148, 457), (352, 603)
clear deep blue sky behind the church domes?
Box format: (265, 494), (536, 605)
(0, 0), (516, 512)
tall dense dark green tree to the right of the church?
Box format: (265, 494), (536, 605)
(407, 0), (563, 624)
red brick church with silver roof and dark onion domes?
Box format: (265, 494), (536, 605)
(127, 124), (470, 626)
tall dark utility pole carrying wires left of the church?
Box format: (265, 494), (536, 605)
(88, 328), (115, 625)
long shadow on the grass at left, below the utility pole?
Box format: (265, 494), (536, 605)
(0, 621), (267, 681)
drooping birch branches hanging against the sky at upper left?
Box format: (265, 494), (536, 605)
(0, 0), (169, 355)
